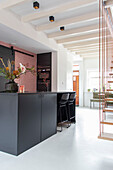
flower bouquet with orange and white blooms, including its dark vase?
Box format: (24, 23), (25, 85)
(0, 57), (35, 92)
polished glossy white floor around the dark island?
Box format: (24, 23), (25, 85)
(0, 108), (113, 170)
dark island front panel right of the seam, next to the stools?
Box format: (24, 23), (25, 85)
(41, 94), (57, 141)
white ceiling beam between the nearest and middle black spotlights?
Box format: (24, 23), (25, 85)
(22, 0), (97, 22)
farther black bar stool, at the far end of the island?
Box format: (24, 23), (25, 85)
(68, 93), (76, 122)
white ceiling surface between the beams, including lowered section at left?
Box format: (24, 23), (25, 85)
(0, 0), (109, 57)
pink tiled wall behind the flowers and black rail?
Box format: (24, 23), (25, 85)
(0, 42), (37, 92)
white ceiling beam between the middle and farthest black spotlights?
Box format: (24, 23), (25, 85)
(36, 12), (99, 31)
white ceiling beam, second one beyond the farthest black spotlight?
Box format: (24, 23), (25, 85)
(56, 31), (99, 44)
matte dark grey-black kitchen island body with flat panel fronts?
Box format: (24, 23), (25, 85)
(0, 92), (76, 155)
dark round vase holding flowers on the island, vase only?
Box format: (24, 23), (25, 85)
(5, 80), (18, 93)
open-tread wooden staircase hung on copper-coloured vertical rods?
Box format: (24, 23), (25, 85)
(98, 0), (113, 141)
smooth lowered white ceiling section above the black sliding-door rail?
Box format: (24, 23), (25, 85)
(0, 24), (53, 54)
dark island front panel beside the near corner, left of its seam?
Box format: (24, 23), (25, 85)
(18, 94), (41, 154)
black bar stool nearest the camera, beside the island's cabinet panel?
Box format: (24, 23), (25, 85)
(58, 93), (69, 132)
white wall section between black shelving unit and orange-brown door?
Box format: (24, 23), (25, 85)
(57, 46), (73, 91)
